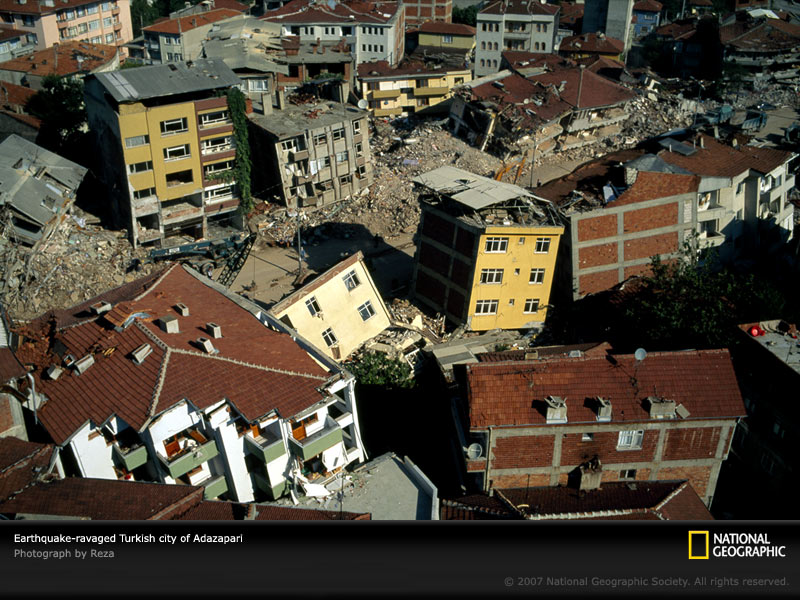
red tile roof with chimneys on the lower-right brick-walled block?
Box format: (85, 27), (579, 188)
(466, 350), (746, 429)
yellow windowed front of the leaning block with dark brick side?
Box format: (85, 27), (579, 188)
(467, 227), (564, 331)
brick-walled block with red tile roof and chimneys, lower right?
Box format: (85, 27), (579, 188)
(456, 350), (745, 506)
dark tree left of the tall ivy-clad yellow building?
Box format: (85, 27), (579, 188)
(25, 75), (86, 154)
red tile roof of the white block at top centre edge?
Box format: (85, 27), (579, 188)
(261, 0), (400, 24)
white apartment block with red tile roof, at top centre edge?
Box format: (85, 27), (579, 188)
(261, 0), (405, 66)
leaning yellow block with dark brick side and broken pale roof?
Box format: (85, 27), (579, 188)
(413, 167), (564, 331)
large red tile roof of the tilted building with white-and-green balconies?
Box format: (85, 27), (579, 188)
(18, 266), (328, 443)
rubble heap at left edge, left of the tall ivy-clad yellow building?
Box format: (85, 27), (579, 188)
(0, 207), (162, 321)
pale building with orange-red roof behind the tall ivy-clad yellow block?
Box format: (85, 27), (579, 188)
(142, 8), (242, 64)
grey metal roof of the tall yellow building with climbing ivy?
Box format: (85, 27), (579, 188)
(94, 59), (241, 102)
